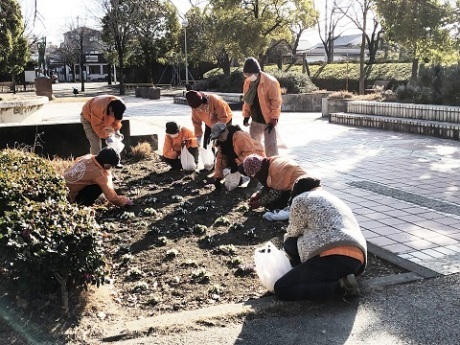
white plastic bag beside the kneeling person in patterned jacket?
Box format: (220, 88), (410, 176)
(254, 241), (292, 292)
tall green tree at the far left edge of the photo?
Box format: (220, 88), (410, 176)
(0, 0), (30, 92)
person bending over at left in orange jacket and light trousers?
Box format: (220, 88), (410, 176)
(80, 95), (126, 155)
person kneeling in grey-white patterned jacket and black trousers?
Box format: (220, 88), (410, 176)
(274, 175), (367, 300)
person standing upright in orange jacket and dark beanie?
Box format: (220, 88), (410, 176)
(243, 57), (283, 157)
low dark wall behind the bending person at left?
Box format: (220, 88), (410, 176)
(0, 120), (158, 158)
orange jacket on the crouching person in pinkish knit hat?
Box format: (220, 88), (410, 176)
(267, 156), (307, 191)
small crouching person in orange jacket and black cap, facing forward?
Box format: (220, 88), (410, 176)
(162, 121), (198, 170)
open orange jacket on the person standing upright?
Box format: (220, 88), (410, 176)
(243, 72), (283, 123)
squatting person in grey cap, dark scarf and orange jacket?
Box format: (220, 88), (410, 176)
(210, 122), (264, 187)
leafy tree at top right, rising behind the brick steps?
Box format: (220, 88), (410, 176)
(376, 0), (450, 78)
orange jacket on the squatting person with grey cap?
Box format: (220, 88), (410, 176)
(214, 131), (265, 179)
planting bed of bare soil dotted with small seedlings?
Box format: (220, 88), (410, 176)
(0, 154), (403, 344)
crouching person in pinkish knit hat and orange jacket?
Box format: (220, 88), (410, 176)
(243, 154), (307, 211)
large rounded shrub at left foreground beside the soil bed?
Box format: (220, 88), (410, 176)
(0, 150), (105, 312)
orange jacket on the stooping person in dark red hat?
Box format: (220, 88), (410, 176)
(192, 93), (233, 137)
